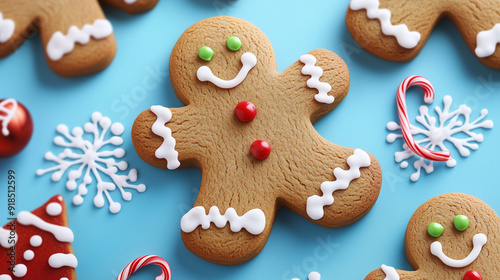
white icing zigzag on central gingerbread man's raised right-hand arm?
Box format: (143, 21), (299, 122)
(300, 54), (335, 104)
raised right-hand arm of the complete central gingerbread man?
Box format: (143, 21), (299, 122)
(277, 49), (350, 122)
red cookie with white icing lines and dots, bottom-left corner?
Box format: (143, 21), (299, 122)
(0, 196), (78, 280)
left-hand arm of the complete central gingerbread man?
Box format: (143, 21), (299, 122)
(132, 105), (205, 169)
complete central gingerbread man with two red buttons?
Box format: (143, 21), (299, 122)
(132, 17), (382, 265)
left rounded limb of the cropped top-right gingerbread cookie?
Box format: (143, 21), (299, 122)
(346, 0), (442, 62)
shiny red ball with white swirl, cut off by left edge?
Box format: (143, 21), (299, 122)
(0, 99), (33, 158)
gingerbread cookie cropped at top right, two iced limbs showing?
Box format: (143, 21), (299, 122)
(346, 0), (500, 69)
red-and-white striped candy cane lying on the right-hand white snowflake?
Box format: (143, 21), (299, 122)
(396, 76), (450, 161)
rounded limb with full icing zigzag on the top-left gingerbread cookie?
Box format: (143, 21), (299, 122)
(39, 0), (116, 77)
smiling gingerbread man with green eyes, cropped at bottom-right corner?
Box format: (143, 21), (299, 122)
(365, 193), (500, 280)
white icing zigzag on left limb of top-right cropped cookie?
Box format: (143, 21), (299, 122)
(350, 0), (421, 49)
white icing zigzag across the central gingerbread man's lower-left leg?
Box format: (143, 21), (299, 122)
(181, 206), (266, 235)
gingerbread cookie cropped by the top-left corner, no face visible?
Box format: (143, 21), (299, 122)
(0, 0), (158, 77)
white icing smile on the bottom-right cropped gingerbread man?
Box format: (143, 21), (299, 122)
(431, 233), (488, 268)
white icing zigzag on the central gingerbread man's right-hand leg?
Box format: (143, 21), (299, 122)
(307, 149), (371, 220)
